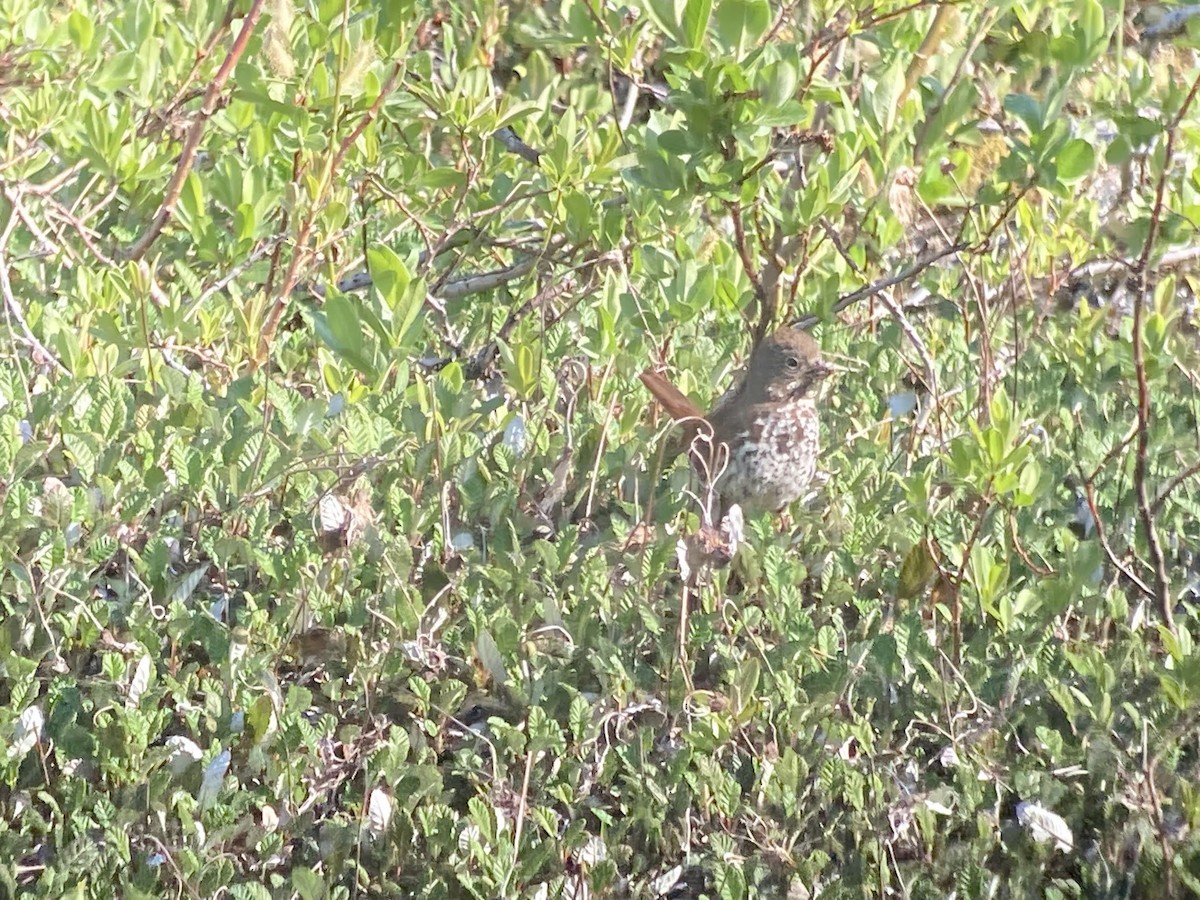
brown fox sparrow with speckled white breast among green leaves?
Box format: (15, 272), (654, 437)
(642, 328), (830, 512)
